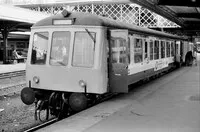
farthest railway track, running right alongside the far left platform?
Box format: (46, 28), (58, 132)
(0, 70), (26, 79)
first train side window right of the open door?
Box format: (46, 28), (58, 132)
(134, 39), (143, 63)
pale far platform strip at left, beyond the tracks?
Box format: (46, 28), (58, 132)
(0, 63), (26, 74)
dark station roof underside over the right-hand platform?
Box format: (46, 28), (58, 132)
(130, 0), (200, 36)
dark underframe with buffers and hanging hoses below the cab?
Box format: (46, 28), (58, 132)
(21, 88), (103, 121)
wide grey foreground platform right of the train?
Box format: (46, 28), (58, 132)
(38, 57), (200, 132)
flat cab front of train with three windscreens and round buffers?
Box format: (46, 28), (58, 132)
(21, 10), (108, 118)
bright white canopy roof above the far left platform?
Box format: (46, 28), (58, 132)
(0, 5), (49, 33)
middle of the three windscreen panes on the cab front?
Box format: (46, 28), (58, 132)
(50, 31), (71, 66)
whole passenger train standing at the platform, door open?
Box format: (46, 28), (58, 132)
(21, 10), (192, 117)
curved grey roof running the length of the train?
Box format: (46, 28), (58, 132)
(33, 10), (184, 39)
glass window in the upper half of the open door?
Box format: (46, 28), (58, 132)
(111, 38), (129, 64)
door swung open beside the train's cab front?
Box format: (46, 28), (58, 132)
(108, 30), (129, 93)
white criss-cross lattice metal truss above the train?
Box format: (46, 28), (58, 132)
(29, 3), (180, 28)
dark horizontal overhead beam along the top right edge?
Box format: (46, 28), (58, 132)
(157, 0), (200, 7)
